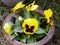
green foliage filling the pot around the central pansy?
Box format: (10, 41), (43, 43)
(4, 9), (50, 43)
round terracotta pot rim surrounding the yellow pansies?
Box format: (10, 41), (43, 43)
(3, 9), (55, 45)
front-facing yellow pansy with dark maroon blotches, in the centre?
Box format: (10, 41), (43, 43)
(22, 18), (38, 34)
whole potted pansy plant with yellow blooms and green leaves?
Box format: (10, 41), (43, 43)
(3, 1), (54, 43)
